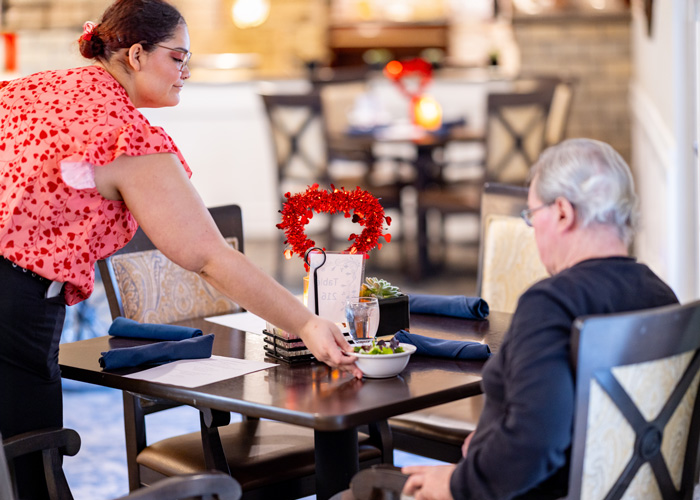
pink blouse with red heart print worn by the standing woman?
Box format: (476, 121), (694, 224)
(0, 66), (191, 305)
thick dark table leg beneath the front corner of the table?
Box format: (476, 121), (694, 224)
(314, 429), (360, 500)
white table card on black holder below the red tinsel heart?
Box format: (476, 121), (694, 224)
(307, 252), (365, 323)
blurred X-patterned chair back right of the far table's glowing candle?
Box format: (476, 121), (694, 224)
(485, 83), (555, 185)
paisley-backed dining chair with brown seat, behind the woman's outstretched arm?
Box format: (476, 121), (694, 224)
(98, 205), (382, 499)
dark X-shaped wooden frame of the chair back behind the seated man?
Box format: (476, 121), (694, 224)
(567, 301), (700, 500)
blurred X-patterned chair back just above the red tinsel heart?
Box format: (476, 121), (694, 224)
(262, 92), (330, 195)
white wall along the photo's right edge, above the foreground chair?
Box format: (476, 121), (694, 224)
(630, 0), (700, 301)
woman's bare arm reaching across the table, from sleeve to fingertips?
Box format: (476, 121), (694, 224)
(95, 153), (362, 377)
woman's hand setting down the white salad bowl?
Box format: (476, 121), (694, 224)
(299, 316), (362, 378)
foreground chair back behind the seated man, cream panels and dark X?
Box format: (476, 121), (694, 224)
(567, 301), (700, 500)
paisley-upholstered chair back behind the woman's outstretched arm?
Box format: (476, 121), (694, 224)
(98, 205), (243, 323)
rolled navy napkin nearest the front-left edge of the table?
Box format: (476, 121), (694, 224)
(100, 333), (214, 370)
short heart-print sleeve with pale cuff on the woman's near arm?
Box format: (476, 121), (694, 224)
(61, 123), (192, 189)
